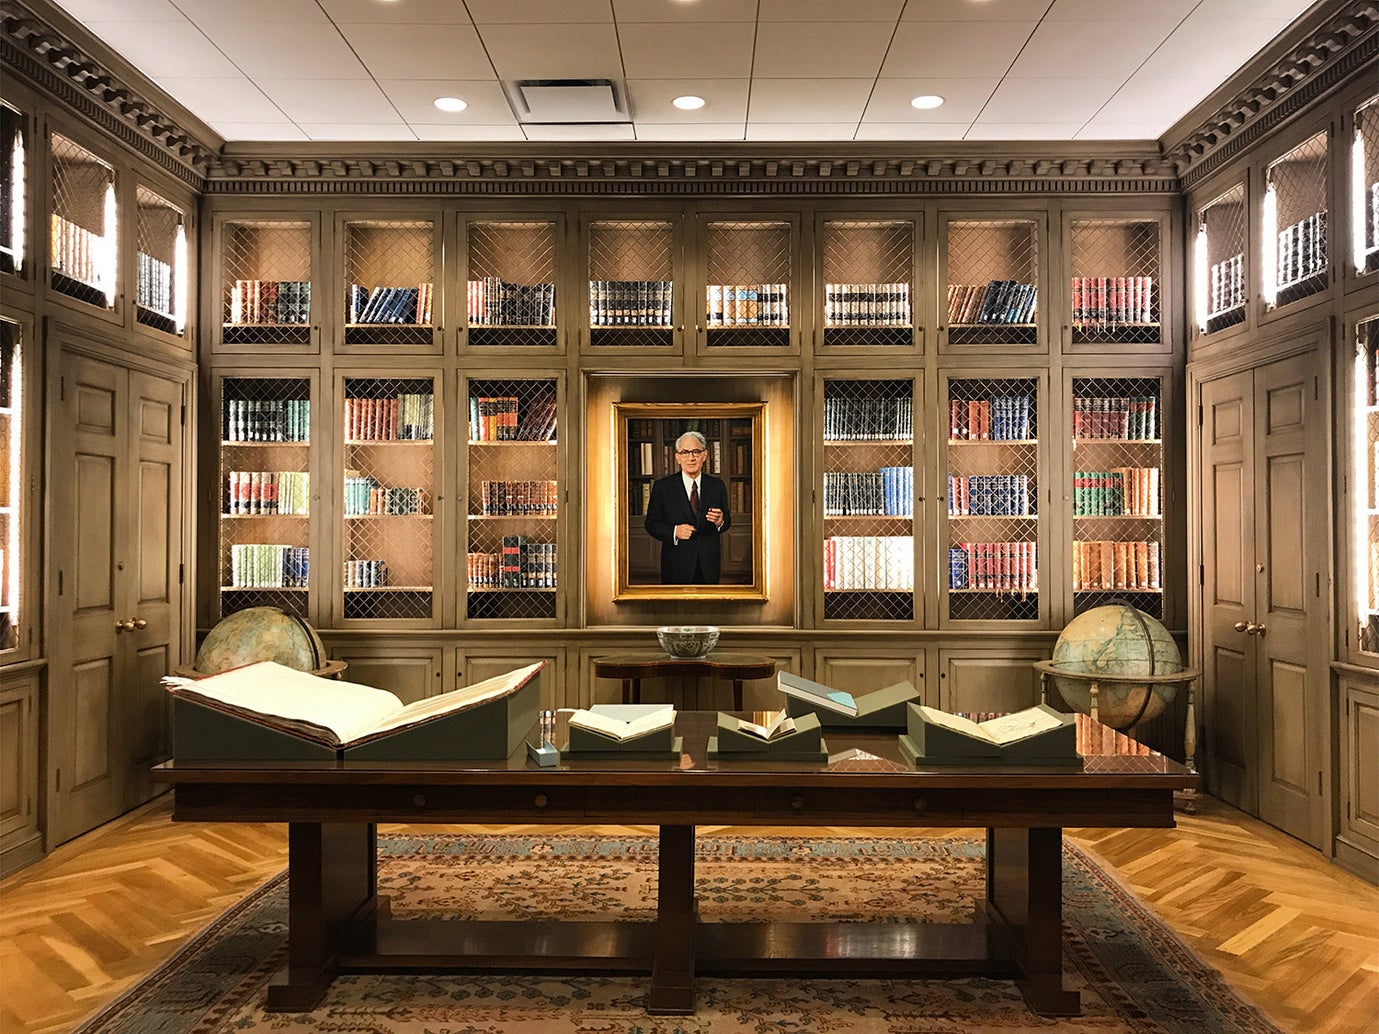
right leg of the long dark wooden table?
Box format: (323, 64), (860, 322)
(986, 829), (1083, 1016)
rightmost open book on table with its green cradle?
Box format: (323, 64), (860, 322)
(900, 703), (1081, 765)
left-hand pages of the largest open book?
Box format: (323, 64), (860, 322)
(163, 660), (403, 746)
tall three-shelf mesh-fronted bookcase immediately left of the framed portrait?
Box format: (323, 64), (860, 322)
(465, 378), (561, 620)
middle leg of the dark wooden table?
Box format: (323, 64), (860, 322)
(647, 826), (698, 1016)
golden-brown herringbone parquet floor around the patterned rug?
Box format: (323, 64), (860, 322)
(0, 797), (1379, 1034)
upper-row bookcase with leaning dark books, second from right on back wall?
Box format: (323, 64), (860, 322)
(940, 216), (1040, 346)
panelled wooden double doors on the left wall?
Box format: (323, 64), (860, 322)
(48, 352), (185, 844)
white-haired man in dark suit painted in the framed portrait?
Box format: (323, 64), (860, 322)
(645, 432), (732, 585)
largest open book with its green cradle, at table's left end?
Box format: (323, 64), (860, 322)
(163, 660), (546, 761)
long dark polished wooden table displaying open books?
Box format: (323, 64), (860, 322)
(154, 711), (1197, 1016)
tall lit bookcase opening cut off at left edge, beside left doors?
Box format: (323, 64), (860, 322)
(0, 318), (28, 659)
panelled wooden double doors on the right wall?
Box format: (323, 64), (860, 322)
(1201, 354), (1328, 847)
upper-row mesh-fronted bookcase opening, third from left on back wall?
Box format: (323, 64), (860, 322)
(465, 219), (557, 349)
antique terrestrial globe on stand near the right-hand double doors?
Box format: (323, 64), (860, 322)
(1049, 604), (1183, 731)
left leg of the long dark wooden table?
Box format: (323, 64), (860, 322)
(268, 822), (378, 1012)
